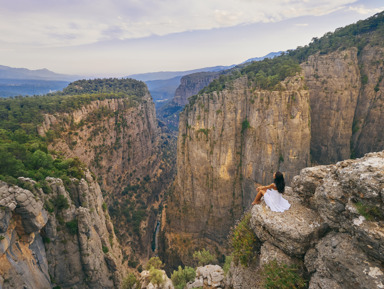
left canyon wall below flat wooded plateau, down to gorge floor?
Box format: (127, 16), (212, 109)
(39, 84), (174, 262)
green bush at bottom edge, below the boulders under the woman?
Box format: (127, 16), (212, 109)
(261, 260), (306, 289)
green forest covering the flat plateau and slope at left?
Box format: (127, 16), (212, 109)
(0, 79), (147, 183)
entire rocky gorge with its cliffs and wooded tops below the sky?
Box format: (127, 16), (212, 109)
(0, 13), (384, 288)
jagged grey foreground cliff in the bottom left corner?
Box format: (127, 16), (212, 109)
(0, 173), (124, 288)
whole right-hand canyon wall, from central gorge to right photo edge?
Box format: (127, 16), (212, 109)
(164, 45), (384, 266)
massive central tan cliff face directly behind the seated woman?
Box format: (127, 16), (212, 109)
(167, 75), (310, 264)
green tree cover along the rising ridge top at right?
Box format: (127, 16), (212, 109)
(189, 12), (384, 105)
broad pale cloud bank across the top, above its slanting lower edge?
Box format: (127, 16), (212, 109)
(0, 0), (364, 46)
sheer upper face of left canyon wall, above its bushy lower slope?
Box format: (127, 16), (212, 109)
(39, 93), (159, 190)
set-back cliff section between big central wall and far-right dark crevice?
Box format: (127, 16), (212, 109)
(302, 49), (360, 164)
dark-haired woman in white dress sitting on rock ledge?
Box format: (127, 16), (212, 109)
(252, 172), (291, 212)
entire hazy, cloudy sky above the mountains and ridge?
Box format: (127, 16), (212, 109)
(0, 0), (384, 76)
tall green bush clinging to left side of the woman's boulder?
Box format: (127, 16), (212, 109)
(229, 213), (259, 267)
